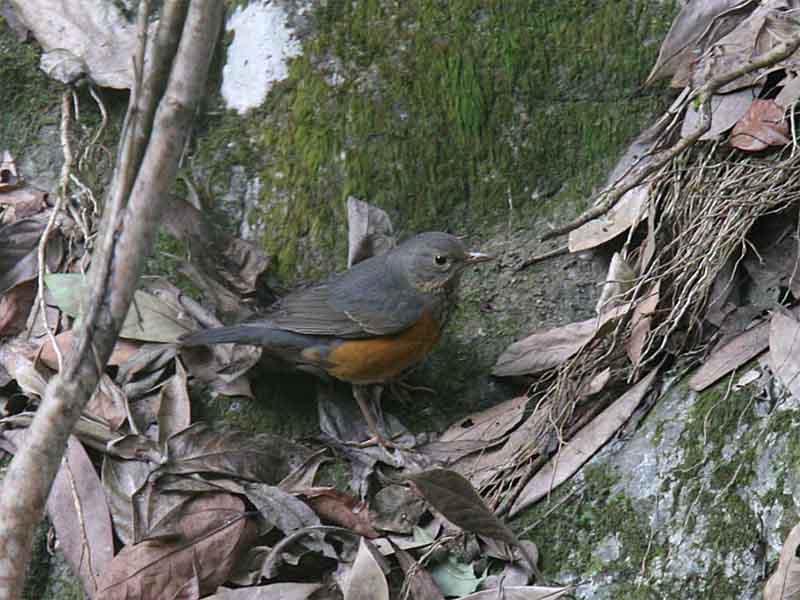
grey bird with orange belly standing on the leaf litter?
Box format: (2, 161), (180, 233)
(179, 232), (494, 448)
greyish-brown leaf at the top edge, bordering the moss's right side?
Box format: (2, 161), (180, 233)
(645, 0), (755, 88)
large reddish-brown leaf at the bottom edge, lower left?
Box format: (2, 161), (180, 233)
(97, 494), (257, 600)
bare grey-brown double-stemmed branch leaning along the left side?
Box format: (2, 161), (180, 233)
(0, 0), (224, 600)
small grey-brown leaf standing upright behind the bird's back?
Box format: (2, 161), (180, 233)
(347, 196), (395, 269)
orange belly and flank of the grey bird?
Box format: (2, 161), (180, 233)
(325, 313), (441, 384)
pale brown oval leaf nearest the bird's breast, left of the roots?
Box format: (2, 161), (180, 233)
(492, 319), (597, 377)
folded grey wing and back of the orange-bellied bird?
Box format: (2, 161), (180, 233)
(268, 257), (425, 339)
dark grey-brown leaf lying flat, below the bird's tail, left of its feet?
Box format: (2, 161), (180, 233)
(155, 423), (311, 485)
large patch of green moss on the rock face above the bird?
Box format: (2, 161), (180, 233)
(191, 0), (675, 278)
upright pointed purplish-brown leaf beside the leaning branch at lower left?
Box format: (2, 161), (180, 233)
(47, 436), (114, 597)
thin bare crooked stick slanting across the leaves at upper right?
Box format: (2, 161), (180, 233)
(542, 34), (800, 241)
